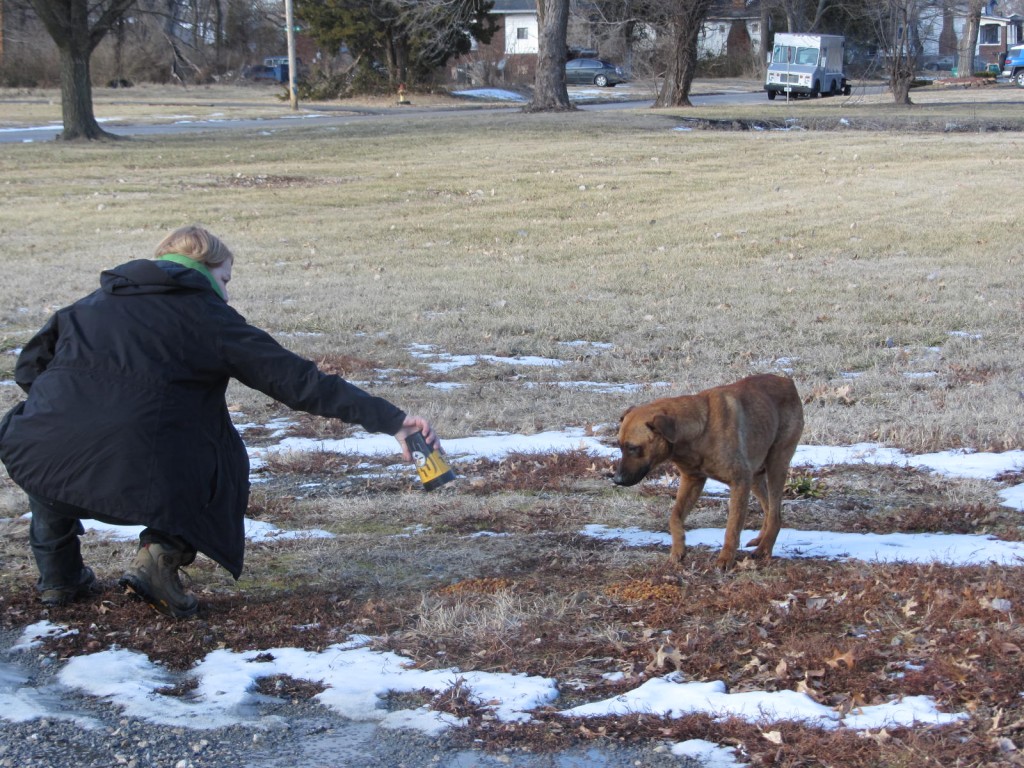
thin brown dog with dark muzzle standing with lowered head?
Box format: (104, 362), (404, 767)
(612, 374), (804, 569)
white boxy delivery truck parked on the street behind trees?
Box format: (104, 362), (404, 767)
(765, 32), (850, 98)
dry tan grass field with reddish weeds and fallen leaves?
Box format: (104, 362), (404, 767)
(0, 81), (1024, 768)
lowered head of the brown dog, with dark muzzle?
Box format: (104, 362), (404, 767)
(611, 400), (694, 485)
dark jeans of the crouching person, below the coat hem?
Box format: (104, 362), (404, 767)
(29, 494), (196, 591)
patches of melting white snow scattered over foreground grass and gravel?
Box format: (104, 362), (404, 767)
(0, 346), (1024, 766)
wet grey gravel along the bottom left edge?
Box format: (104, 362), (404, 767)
(0, 632), (698, 768)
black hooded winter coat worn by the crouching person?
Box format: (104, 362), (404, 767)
(0, 259), (406, 579)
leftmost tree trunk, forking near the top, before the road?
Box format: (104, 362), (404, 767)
(32, 0), (135, 141)
